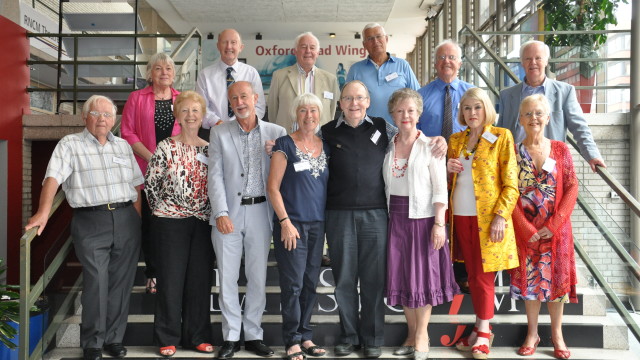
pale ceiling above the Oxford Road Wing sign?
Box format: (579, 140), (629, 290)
(147, 0), (443, 57)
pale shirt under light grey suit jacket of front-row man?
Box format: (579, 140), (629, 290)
(238, 123), (265, 197)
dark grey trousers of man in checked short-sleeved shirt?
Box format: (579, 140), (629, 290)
(71, 206), (140, 349)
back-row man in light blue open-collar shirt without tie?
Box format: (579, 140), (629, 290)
(347, 23), (420, 124)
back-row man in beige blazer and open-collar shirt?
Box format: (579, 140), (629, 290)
(267, 32), (340, 133)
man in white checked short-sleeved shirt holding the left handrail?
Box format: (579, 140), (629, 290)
(26, 95), (144, 360)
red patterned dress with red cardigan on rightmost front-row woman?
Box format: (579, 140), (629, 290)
(510, 140), (578, 302)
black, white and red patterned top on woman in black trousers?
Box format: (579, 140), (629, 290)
(145, 138), (211, 221)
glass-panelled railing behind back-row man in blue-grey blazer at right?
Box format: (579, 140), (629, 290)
(459, 26), (631, 113)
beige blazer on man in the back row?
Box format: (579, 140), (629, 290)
(267, 64), (340, 134)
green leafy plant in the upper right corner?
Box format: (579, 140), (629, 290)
(542, 0), (627, 77)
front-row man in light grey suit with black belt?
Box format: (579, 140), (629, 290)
(209, 81), (286, 359)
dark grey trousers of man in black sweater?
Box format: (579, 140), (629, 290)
(325, 209), (388, 346)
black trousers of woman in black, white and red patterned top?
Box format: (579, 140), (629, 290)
(151, 216), (213, 348)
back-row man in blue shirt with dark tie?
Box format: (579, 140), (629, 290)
(418, 40), (475, 141)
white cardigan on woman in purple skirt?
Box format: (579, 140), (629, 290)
(382, 133), (448, 219)
